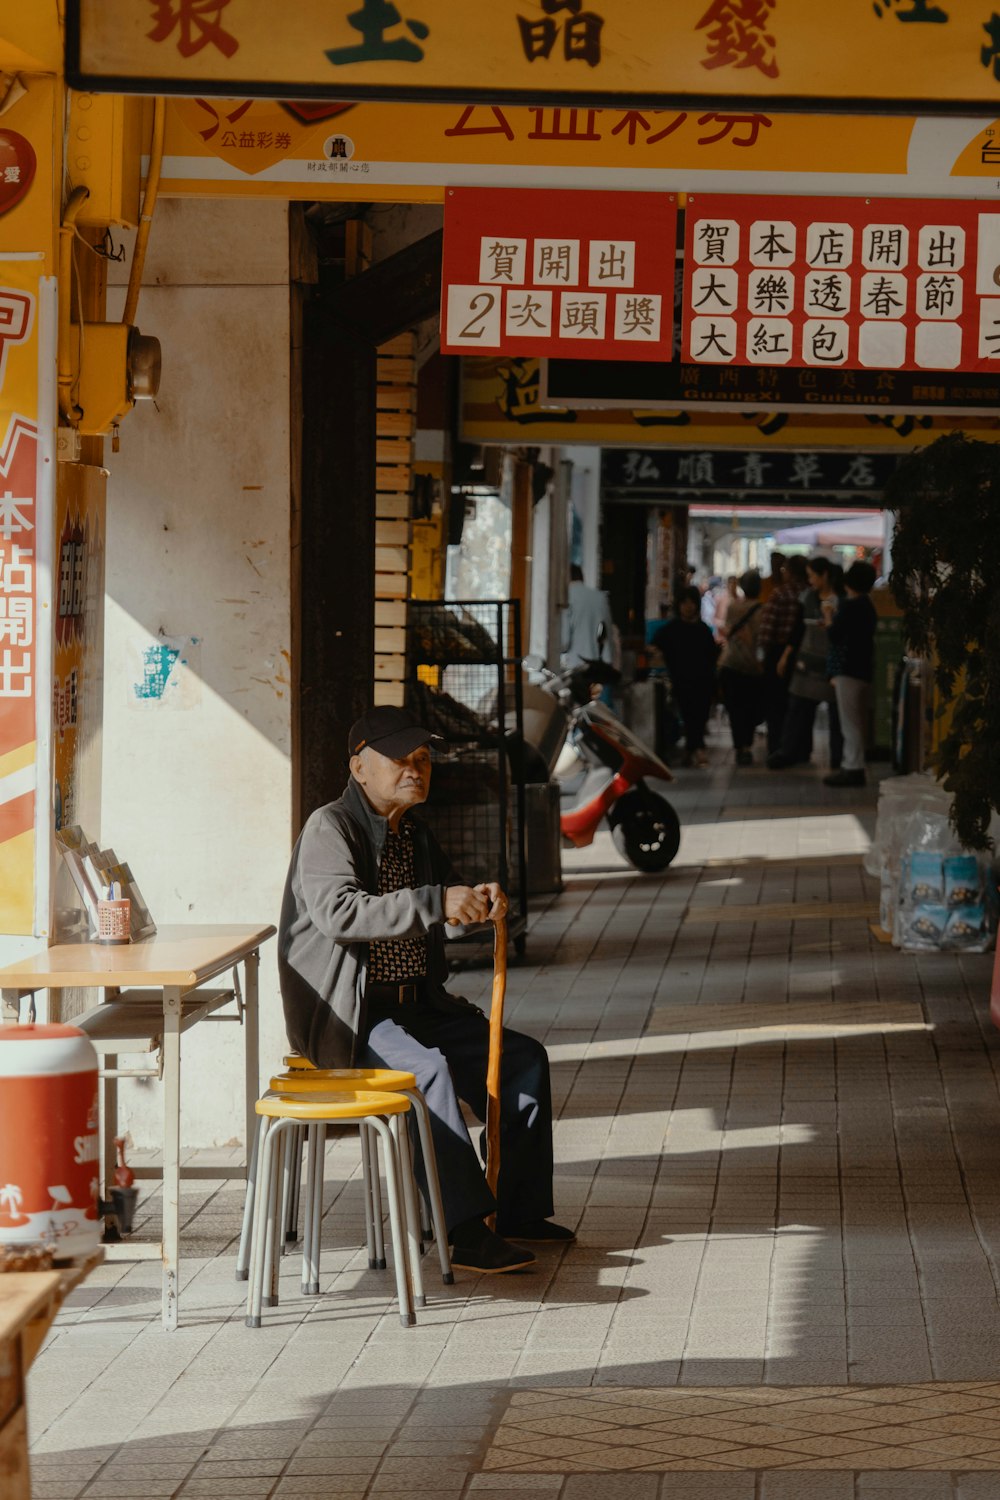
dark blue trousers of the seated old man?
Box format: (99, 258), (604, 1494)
(358, 1001), (552, 1233)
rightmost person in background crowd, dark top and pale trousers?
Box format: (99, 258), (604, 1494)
(823, 563), (877, 786)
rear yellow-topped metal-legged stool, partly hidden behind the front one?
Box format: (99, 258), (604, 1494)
(268, 1068), (454, 1307)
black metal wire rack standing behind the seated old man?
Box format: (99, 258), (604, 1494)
(406, 599), (528, 954)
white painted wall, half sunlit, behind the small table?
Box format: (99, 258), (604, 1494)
(100, 200), (291, 1146)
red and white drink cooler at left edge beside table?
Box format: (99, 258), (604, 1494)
(0, 1026), (100, 1260)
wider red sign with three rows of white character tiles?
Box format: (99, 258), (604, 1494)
(682, 194), (1000, 371)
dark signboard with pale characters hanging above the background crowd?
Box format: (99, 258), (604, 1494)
(601, 449), (900, 509)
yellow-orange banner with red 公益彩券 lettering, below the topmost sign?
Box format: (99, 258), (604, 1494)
(154, 96), (1000, 203)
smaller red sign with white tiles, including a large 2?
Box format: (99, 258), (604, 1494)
(441, 188), (676, 360)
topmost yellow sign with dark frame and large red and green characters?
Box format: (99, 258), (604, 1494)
(66, 0), (1000, 114)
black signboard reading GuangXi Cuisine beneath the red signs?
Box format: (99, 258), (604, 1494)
(541, 359), (1000, 416)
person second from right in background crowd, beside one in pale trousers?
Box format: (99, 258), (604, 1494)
(768, 557), (844, 771)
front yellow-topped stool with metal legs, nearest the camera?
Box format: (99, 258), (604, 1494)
(246, 1089), (420, 1328)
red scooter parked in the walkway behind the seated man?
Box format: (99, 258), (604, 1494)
(525, 662), (681, 873)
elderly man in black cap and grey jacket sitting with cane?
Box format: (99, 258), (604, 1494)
(279, 708), (574, 1274)
